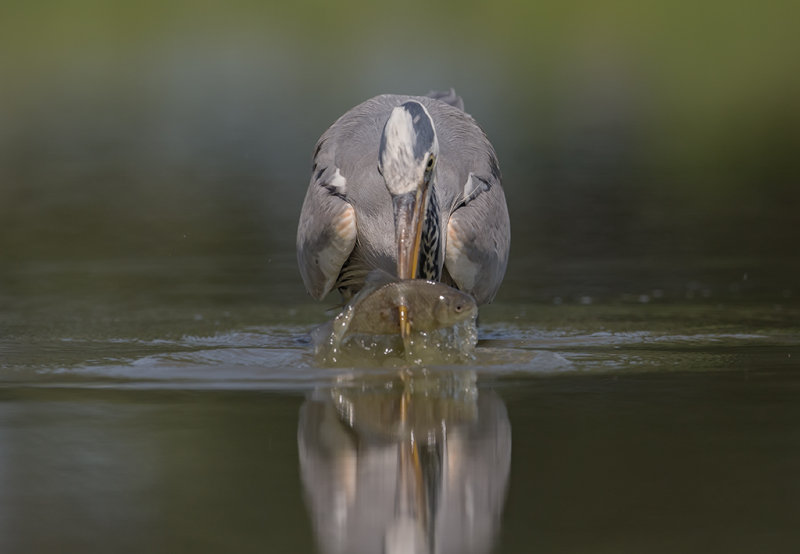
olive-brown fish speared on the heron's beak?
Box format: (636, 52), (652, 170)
(342, 270), (478, 335)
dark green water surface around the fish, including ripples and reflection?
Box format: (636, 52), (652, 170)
(0, 255), (800, 553)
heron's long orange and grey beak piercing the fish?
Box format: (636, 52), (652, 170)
(393, 178), (430, 341)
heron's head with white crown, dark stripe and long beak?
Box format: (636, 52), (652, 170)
(378, 100), (439, 279)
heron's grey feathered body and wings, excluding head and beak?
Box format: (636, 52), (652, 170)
(297, 90), (510, 303)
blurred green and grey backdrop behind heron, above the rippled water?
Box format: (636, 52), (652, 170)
(0, 0), (800, 294)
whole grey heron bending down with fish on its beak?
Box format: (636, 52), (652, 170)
(297, 89), (510, 321)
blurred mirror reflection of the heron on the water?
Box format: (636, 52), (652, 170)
(297, 372), (511, 554)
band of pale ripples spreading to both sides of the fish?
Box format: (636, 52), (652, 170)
(0, 323), (800, 390)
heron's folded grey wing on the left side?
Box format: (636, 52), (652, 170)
(297, 137), (357, 300)
